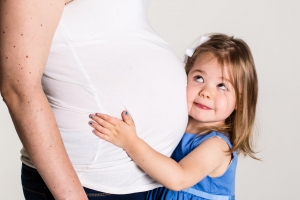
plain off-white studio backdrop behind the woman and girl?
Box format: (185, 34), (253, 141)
(0, 0), (300, 200)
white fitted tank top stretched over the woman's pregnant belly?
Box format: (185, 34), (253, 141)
(21, 0), (188, 194)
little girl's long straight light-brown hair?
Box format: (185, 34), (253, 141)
(185, 34), (258, 159)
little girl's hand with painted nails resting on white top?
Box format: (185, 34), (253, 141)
(89, 111), (139, 151)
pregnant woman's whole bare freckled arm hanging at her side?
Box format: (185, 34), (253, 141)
(0, 0), (87, 200)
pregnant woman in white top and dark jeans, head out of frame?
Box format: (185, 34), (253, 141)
(0, 0), (187, 200)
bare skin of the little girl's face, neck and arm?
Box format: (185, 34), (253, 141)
(89, 53), (235, 190)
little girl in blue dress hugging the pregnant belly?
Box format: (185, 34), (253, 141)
(90, 34), (258, 200)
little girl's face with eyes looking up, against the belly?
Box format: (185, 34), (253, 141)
(187, 53), (236, 127)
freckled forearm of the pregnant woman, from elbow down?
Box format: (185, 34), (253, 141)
(4, 89), (86, 200)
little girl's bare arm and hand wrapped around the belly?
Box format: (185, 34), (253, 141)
(90, 112), (230, 190)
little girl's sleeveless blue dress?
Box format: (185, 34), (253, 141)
(147, 131), (238, 200)
